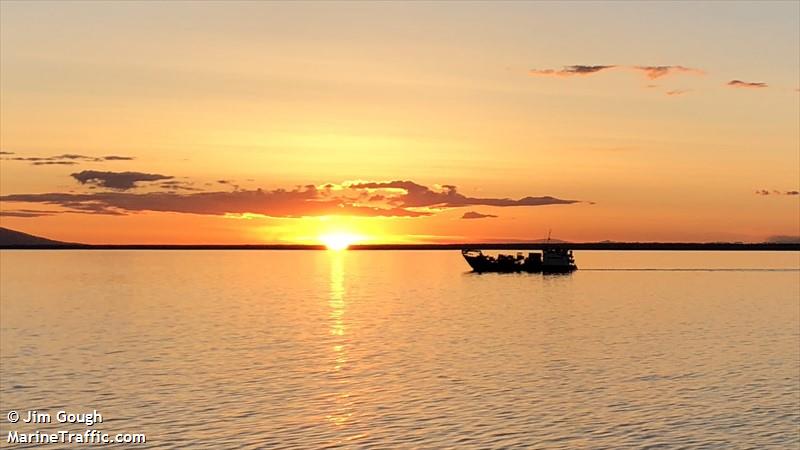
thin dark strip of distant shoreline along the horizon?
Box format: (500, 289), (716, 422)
(0, 242), (800, 251)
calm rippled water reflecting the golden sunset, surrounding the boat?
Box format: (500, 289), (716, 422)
(0, 251), (800, 449)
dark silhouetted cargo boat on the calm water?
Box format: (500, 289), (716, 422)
(461, 247), (578, 273)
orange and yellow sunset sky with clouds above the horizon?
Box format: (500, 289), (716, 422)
(0, 0), (800, 244)
